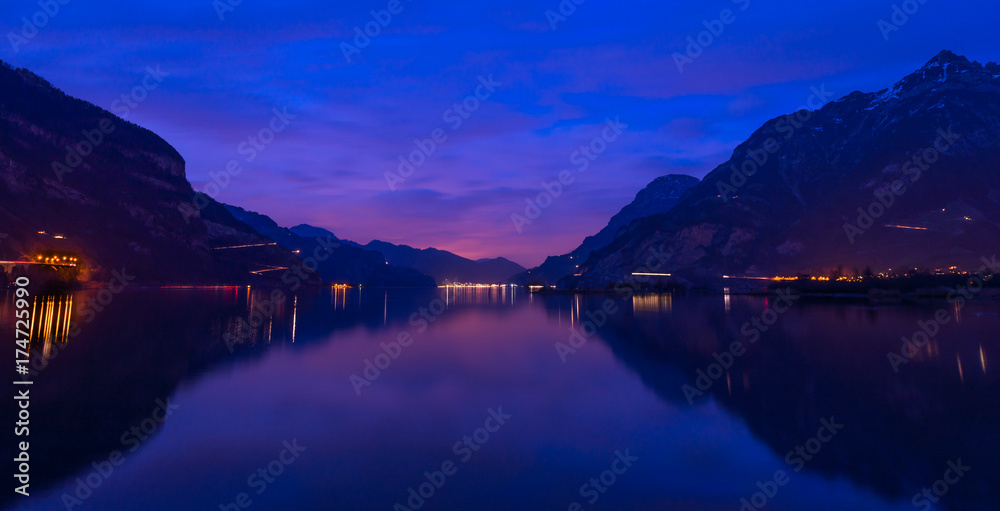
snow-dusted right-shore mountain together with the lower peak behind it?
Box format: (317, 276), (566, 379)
(562, 51), (1000, 287)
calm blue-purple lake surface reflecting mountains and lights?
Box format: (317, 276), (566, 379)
(0, 288), (1000, 511)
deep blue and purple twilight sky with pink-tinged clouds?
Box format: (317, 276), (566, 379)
(0, 0), (1000, 267)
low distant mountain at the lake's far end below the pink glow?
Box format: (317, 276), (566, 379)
(364, 240), (524, 284)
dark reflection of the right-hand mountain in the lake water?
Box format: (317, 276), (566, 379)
(564, 298), (1000, 510)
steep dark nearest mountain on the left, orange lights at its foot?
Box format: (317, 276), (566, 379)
(0, 62), (296, 285)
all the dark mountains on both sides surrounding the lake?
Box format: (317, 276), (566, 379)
(0, 51), (1000, 288)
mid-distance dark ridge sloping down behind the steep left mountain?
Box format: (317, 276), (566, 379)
(225, 205), (436, 287)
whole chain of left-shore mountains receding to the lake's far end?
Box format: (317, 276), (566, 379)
(0, 62), (498, 287)
